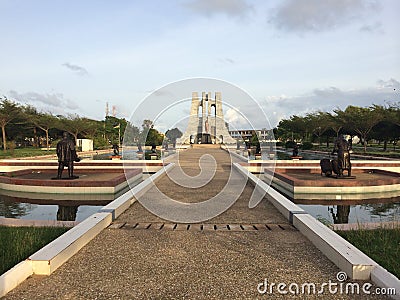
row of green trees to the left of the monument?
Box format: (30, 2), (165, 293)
(0, 97), (180, 151)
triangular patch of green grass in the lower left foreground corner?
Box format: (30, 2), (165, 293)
(0, 226), (69, 274)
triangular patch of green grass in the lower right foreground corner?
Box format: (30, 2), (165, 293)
(336, 226), (400, 278)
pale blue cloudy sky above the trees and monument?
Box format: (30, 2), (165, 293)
(0, 0), (400, 128)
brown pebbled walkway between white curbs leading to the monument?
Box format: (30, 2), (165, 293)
(5, 149), (388, 299)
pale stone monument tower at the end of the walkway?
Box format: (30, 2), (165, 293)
(178, 92), (236, 144)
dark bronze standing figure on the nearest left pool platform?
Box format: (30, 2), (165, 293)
(57, 132), (80, 179)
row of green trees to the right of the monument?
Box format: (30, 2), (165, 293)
(274, 102), (400, 152)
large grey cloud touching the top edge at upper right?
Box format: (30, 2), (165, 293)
(269, 0), (380, 32)
